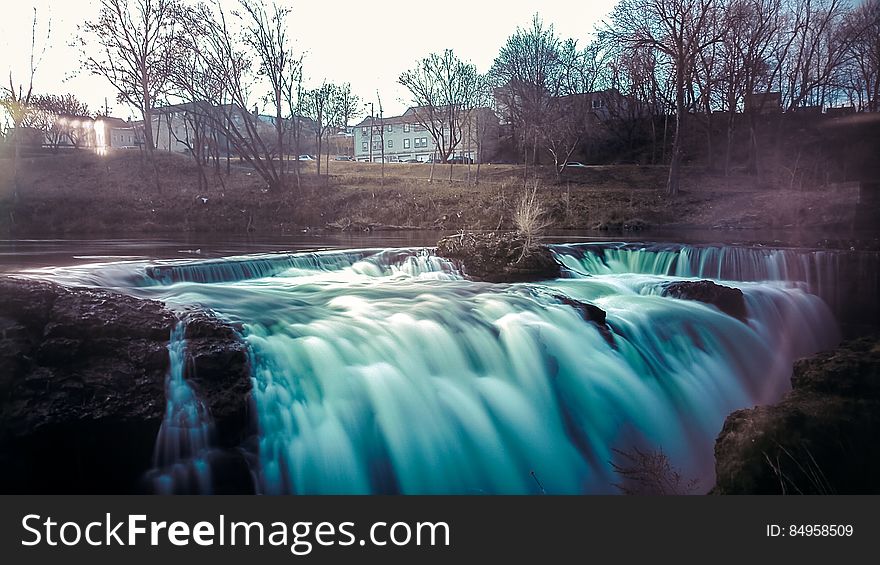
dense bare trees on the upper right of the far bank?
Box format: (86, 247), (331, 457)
(597, 0), (880, 194)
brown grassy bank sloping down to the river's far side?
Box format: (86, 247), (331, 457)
(0, 152), (858, 235)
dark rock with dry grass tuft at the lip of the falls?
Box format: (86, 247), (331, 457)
(437, 232), (561, 282)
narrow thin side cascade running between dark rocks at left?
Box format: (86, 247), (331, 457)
(149, 322), (214, 494)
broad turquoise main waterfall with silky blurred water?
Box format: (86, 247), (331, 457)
(12, 240), (838, 493)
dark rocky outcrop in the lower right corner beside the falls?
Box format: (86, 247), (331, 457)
(713, 336), (880, 494)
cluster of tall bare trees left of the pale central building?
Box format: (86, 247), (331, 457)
(80, 0), (358, 190)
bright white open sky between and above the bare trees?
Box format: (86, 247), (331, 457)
(0, 0), (615, 118)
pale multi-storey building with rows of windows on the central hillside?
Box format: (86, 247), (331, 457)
(354, 104), (498, 163)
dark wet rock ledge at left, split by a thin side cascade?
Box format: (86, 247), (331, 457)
(0, 277), (250, 493)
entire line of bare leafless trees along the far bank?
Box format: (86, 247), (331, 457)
(3, 0), (880, 194)
